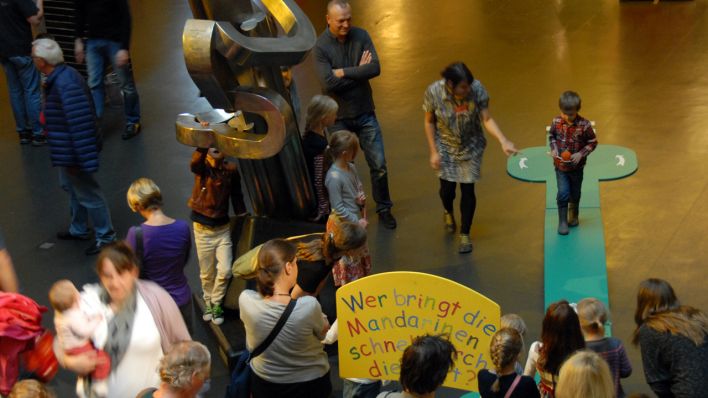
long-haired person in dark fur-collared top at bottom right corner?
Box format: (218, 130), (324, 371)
(633, 278), (708, 398)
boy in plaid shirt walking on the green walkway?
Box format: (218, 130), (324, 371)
(548, 91), (597, 235)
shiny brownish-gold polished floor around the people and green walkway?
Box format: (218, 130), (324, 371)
(0, 0), (708, 397)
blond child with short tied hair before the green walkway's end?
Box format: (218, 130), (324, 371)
(577, 298), (632, 398)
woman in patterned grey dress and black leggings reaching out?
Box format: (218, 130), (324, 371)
(423, 62), (518, 253)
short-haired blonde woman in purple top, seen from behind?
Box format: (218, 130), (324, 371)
(125, 178), (192, 332)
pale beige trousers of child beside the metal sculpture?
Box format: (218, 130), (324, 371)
(192, 222), (233, 305)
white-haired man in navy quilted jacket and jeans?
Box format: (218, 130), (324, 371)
(32, 39), (116, 255)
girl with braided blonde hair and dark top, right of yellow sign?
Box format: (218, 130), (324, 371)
(477, 328), (540, 398)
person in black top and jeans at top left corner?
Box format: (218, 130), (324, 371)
(0, 0), (47, 146)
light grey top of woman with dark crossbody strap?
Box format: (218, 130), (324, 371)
(238, 290), (329, 383)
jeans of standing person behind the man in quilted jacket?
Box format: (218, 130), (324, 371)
(86, 39), (140, 125)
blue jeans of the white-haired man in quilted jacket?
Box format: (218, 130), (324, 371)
(59, 167), (116, 243)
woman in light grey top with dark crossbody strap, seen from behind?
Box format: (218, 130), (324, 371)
(239, 239), (332, 398)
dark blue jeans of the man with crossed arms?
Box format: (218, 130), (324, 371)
(329, 112), (393, 213)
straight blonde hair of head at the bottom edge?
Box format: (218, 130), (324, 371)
(556, 350), (615, 398)
